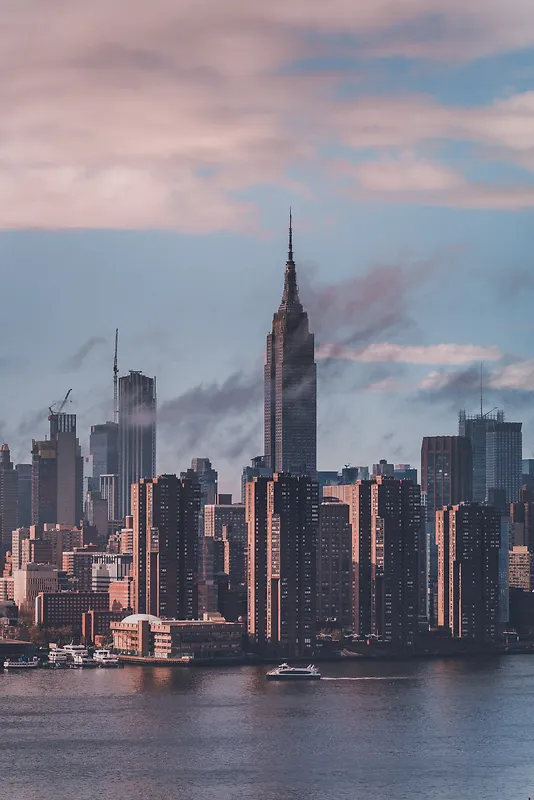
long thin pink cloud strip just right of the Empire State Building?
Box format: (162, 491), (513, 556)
(316, 342), (503, 365)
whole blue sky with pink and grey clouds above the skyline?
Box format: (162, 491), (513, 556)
(0, 0), (534, 491)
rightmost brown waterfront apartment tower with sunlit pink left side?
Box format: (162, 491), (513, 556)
(437, 503), (501, 644)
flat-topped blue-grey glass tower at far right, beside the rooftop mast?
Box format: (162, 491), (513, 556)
(486, 420), (523, 504)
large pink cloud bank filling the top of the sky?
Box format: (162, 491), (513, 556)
(0, 0), (534, 232)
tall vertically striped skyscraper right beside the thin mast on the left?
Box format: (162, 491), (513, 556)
(119, 370), (156, 518)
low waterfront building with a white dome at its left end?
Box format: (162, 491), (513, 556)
(111, 614), (248, 659)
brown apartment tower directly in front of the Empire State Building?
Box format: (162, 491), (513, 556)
(247, 473), (319, 657)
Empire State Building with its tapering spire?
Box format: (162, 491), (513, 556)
(265, 215), (317, 478)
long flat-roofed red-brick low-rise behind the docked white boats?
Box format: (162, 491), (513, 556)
(35, 592), (109, 630)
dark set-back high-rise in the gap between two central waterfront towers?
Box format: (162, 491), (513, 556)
(317, 497), (353, 631)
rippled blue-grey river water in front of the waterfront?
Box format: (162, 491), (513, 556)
(0, 656), (534, 800)
